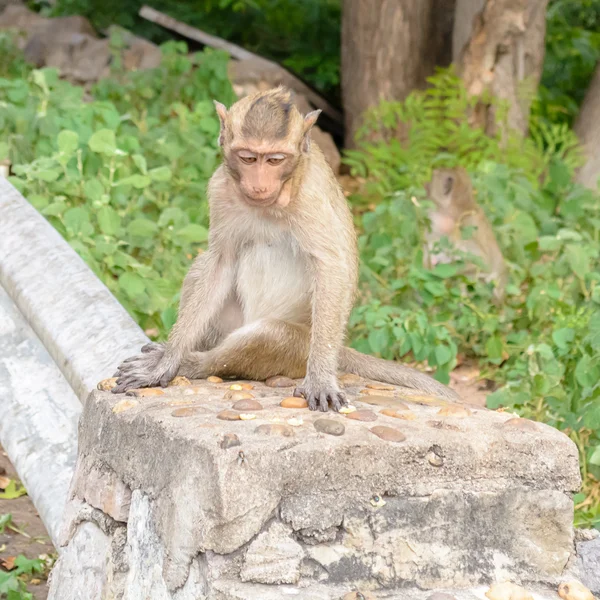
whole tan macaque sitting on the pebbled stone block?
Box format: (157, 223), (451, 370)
(113, 87), (458, 411)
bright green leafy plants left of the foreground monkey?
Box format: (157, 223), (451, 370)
(0, 42), (234, 333)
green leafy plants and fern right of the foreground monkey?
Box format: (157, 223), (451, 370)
(347, 72), (600, 526)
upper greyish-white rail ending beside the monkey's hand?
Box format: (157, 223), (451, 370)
(0, 178), (148, 404)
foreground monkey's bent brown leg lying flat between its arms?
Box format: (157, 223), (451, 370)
(179, 319), (310, 381)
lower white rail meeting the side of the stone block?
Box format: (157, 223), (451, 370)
(0, 286), (81, 546)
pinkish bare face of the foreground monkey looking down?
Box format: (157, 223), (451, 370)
(227, 145), (298, 207)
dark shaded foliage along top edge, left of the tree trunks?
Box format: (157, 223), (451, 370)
(52, 0), (341, 94)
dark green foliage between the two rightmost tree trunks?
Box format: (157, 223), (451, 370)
(535, 0), (600, 124)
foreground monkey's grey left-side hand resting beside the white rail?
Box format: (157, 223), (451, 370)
(112, 342), (179, 394)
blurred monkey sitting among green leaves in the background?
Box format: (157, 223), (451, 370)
(424, 168), (508, 303)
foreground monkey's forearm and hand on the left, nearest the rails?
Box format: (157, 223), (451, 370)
(112, 250), (233, 393)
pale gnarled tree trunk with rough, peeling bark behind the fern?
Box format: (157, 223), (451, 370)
(460, 0), (548, 134)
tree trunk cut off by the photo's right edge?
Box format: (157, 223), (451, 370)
(575, 63), (600, 190)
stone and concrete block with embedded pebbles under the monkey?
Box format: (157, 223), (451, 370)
(50, 376), (580, 600)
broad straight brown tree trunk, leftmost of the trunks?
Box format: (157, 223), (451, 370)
(342, 0), (456, 147)
